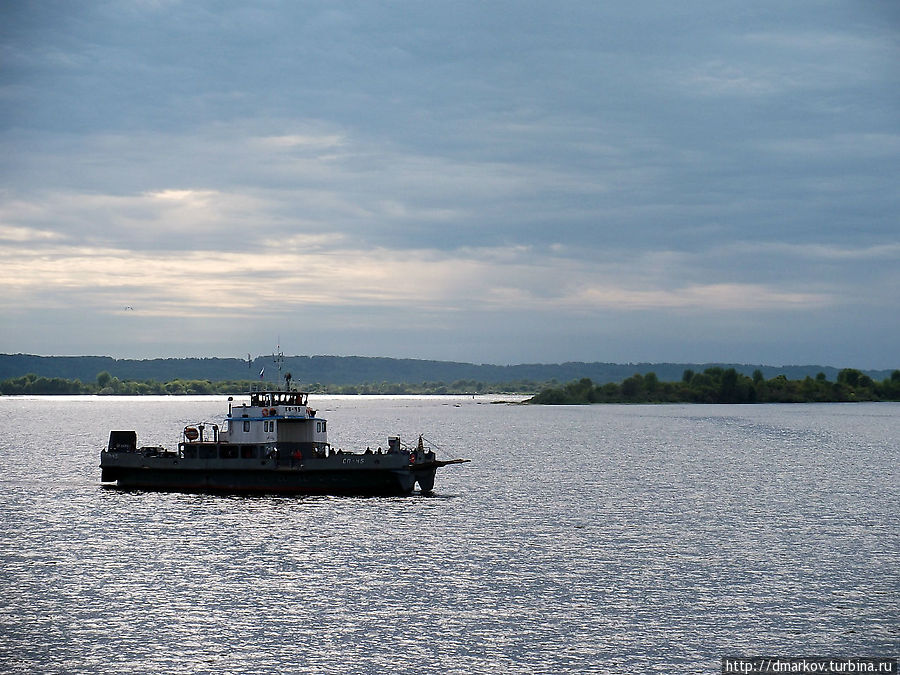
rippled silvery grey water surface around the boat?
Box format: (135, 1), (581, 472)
(0, 397), (900, 673)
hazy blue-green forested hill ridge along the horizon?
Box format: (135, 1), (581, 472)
(0, 354), (891, 386)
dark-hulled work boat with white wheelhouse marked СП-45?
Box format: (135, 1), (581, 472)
(100, 381), (469, 495)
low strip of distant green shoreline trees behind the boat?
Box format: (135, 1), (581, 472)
(0, 371), (546, 396)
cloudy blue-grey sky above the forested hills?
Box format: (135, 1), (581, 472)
(0, 0), (900, 368)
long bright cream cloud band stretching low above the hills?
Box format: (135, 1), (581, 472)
(0, 235), (852, 326)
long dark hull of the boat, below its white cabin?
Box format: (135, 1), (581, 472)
(101, 457), (437, 495)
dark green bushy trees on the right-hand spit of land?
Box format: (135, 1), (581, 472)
(528, 368), (900, 405)
